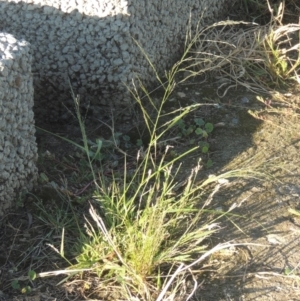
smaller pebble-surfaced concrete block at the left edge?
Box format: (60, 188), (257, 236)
(0, 33), (37, 216)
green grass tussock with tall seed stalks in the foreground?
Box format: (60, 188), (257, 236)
(33, 19), (272, 300)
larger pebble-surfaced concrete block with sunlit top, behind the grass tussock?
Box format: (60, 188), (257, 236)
(0, 0), (227, 121)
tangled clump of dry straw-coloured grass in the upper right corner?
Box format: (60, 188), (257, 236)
(190, 3), (300, 97)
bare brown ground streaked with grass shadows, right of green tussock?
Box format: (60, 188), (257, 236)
(171, 78), (300, 301)
